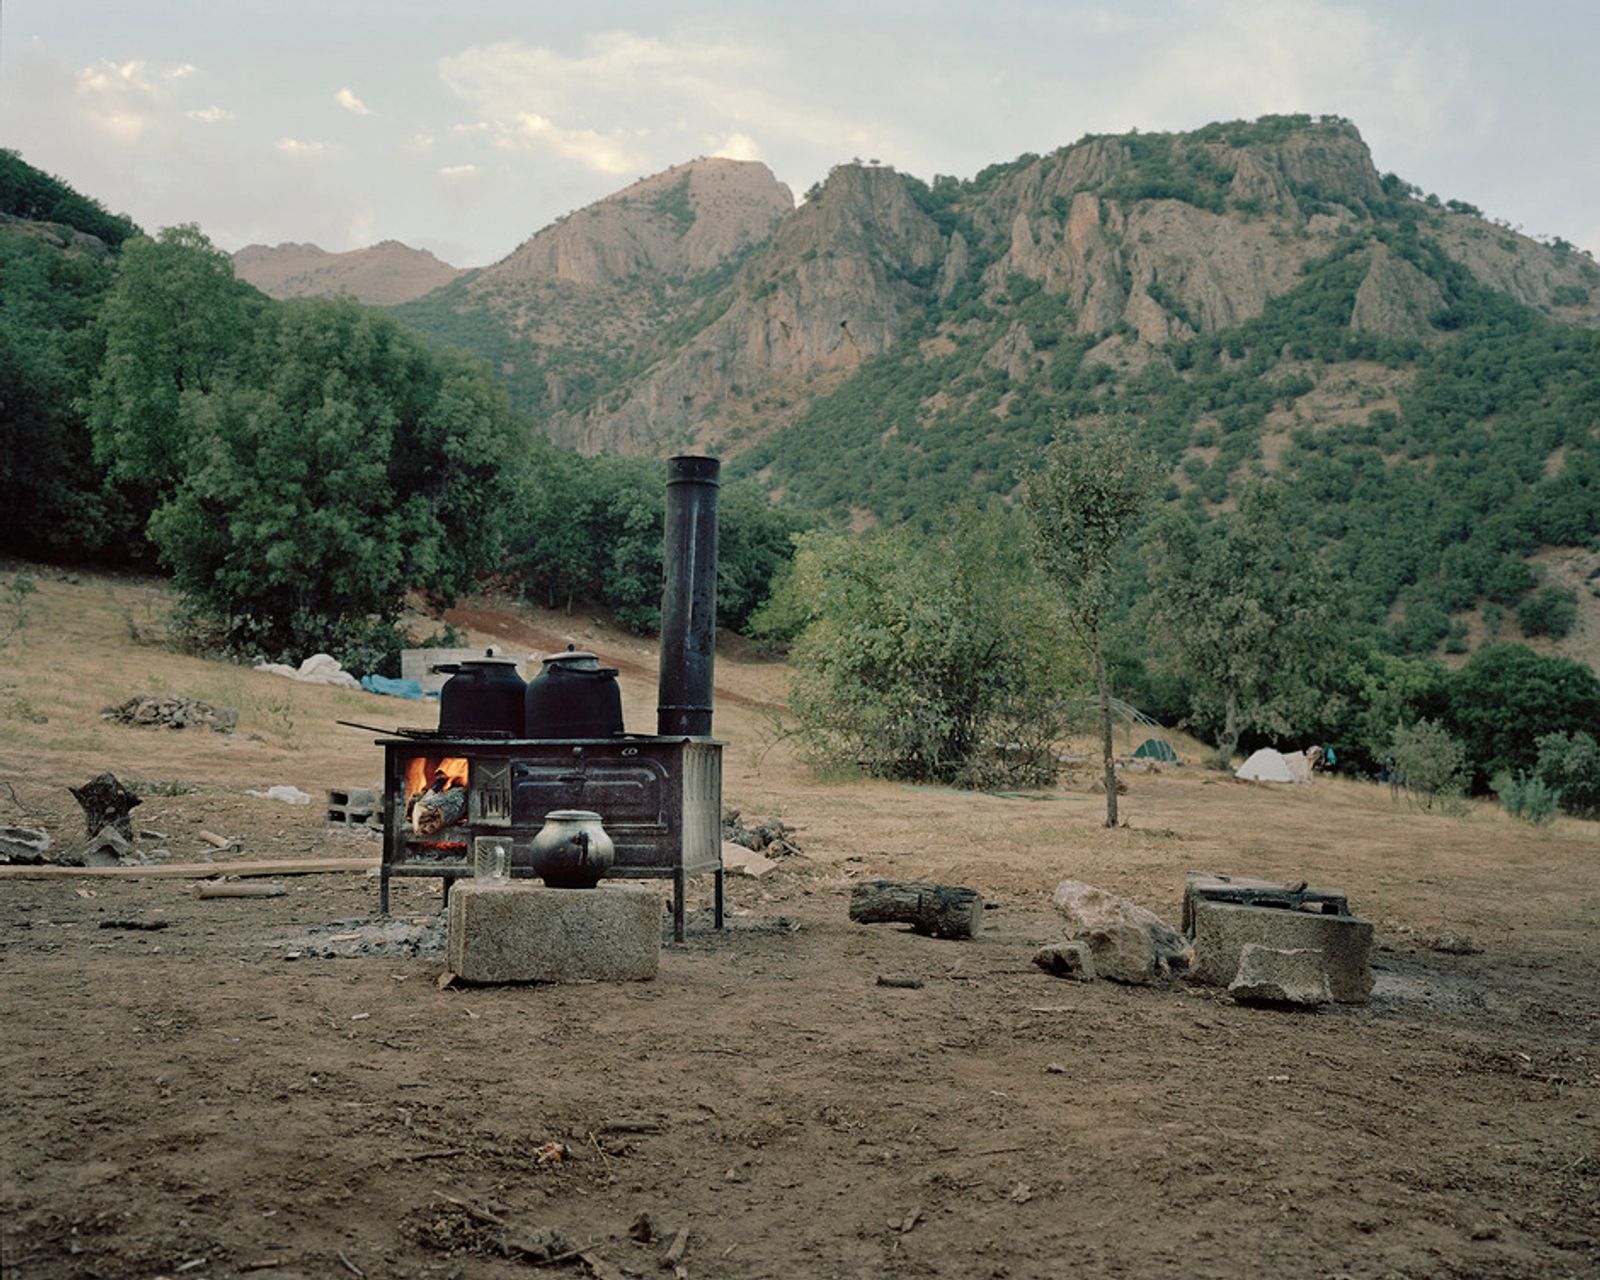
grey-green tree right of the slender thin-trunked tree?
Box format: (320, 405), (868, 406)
(1149, 485), (1346, 765)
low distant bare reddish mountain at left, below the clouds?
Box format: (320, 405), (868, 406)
(234, 240), (462, 307)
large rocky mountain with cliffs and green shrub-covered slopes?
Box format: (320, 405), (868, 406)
(390, 117), (1600, 651)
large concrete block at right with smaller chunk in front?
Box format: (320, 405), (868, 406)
(1194, 901), (1373, 1005)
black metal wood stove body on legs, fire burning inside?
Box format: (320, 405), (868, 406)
(378, 734), (723, 941)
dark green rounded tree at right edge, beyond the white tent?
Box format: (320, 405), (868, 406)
(1446, 643), (1600, 790)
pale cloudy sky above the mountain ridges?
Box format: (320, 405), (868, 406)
(0, 0), (1600, 266)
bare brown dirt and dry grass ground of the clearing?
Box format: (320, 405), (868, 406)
(0, 565), (1600, 1280)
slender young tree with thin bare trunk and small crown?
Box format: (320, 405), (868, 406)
(1021, 421), (1160, 827)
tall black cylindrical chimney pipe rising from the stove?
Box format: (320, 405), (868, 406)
(656, 456), (722, 738)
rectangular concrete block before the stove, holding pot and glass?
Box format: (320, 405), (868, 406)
(446, 880), (661, 982)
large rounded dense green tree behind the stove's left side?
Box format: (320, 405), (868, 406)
(150, 301), (514, 669)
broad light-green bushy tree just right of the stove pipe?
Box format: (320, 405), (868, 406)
(754, 512), (1072, 786)
